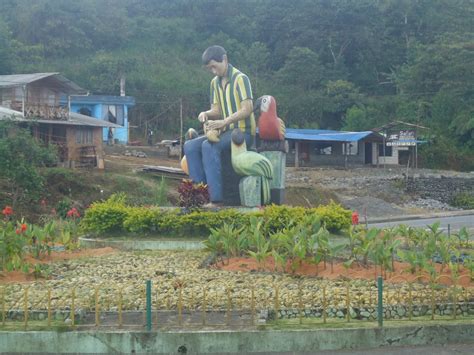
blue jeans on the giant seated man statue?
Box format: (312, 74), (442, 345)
(184, 131), (253, 202)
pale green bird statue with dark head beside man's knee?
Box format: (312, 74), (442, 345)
(231, 128), (273, 204)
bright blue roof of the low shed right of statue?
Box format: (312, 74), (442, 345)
(285, 128), (382, 142)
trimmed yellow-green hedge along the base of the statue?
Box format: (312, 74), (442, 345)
(82, 195), (351, 237)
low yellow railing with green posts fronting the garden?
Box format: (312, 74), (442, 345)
(0, 275), (474, 330)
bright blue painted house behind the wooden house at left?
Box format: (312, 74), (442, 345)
(66, 95), (135, 144)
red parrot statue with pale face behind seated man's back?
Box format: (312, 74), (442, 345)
(257, 95), (285, 141)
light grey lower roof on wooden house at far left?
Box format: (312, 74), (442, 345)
(0, 106), (122, 128)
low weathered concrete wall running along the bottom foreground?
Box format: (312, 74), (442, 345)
(0, 324), (474, 354)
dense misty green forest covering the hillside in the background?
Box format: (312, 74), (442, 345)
(0, 0), (474, 170)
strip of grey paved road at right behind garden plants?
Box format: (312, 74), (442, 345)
(369, 215), (474, 231)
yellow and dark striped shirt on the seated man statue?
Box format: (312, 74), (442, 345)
(211, 64), (255, 135)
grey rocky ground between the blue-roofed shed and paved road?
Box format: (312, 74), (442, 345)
(286, 166), (474, 219)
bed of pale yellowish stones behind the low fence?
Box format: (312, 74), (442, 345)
(4, 251), (474, 324)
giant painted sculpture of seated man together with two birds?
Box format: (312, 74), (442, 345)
(184, 46), (286, 207)
